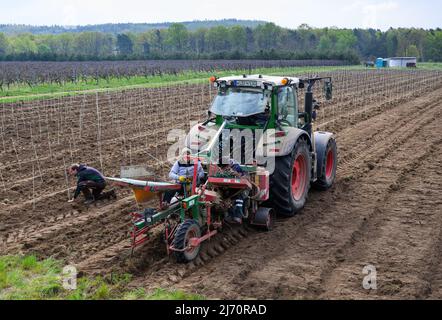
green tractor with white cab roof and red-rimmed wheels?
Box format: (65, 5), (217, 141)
(187, 75), (337, 217)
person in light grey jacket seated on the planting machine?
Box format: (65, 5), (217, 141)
(163, 149), (205, 207)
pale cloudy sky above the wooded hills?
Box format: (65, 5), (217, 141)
(0, 0), (442, 30)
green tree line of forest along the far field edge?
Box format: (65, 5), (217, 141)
(0, 23), (442, 63)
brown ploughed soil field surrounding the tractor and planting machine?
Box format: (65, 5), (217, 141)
(0, 70), (442, 299)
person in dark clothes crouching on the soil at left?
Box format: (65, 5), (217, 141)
(68, 164), (106, 204)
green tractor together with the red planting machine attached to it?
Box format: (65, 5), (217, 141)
(108, 75), (337, 262)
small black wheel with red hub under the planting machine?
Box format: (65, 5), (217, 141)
(173, 219), (201, 263)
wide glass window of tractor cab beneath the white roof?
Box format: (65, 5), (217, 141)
(210, 88), (270, 117)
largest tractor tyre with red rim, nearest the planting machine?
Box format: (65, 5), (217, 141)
(270, 138), (312, 217)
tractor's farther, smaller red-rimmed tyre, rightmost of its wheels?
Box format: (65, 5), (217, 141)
(313, 138), (338, 191)
